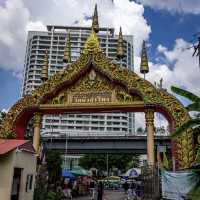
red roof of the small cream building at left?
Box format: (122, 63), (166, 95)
(0, 139), (35, 155)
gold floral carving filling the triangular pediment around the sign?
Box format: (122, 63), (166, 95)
(48, 70), (142, 104)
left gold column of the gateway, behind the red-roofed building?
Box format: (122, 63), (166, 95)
(33, 113), (41, 153)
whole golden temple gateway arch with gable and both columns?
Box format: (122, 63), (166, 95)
(0, 31), (194, 168)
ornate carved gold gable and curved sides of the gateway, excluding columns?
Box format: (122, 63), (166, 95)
(0, 31), (193, 168)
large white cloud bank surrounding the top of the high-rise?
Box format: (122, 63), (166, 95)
(0, 0), (151, 77)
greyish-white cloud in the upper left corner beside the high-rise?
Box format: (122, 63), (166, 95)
(0, 0), (29, 72)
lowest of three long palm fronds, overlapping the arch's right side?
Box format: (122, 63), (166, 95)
(171, 119), (200, 138)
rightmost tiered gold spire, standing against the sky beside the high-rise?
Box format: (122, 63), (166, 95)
(140, 41), (149, 79)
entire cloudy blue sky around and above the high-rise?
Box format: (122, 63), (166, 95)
(0, 0), (200, 110)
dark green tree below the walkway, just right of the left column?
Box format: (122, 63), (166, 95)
(46, 150), (62, 183)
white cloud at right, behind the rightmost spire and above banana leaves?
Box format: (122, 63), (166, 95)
(135, 39), (200, 95)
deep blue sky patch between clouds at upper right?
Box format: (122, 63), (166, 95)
(144, 7), (200, 60)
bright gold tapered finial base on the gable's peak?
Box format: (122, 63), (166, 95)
(82, 29), (102, 54)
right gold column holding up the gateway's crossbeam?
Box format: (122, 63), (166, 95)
(145, 109), (155, 165)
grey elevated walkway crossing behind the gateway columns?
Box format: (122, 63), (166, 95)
(43, 135), (171, 154)
